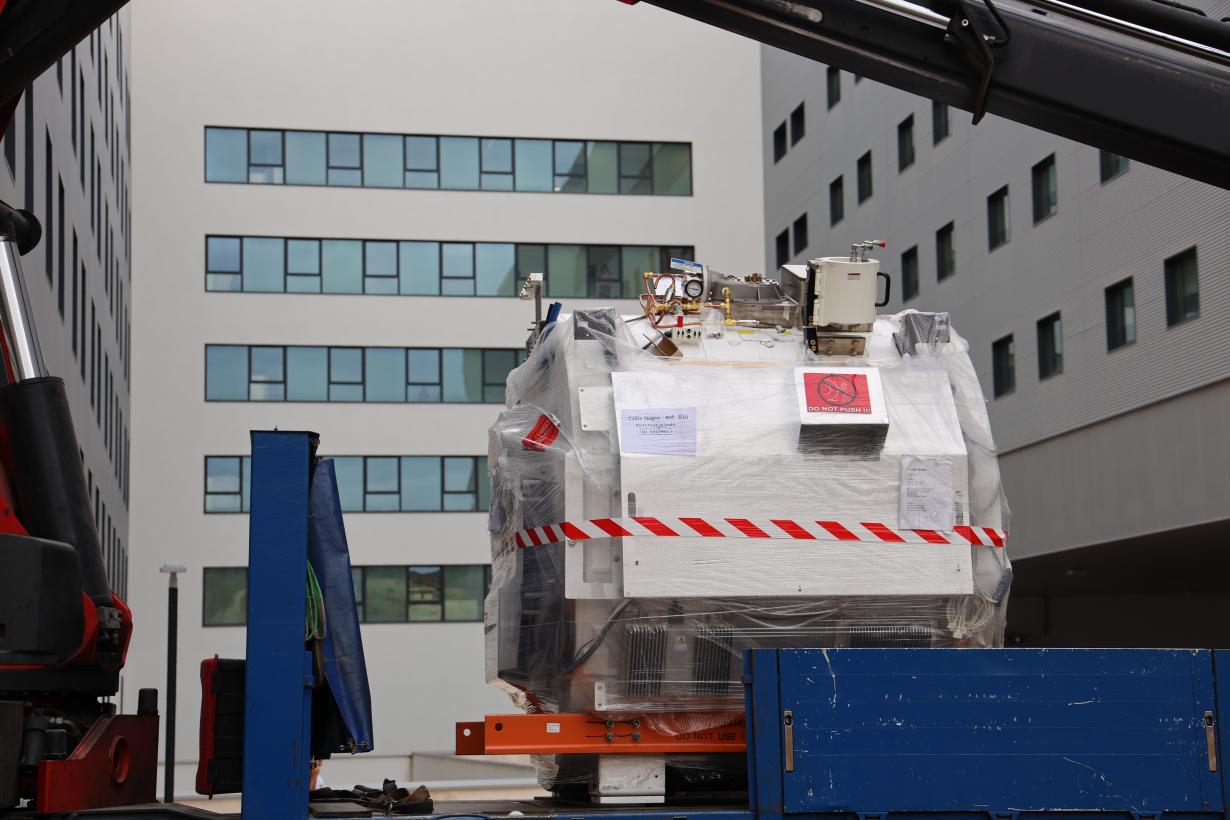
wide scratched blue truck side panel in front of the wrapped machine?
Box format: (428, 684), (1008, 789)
(767, 649), (1223, 815)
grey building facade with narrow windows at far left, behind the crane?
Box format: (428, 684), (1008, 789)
(0, 11), (137, 612)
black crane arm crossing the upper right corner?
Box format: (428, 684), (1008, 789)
(625, 0), (1230, 188)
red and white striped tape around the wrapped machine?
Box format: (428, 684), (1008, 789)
(513, 515), (1006, 550)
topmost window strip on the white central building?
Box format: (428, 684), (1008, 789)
(205, 128), (683, 197)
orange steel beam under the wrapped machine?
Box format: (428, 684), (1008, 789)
(456, 713), (748, 755)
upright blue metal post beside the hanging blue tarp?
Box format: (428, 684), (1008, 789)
(244, 432), (315, 820)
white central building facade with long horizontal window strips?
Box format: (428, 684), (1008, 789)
(128, 0), (763, 793)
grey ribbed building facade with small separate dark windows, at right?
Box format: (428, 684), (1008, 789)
(761, 46), (1230, 645)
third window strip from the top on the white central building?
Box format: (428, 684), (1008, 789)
(205, 344), (525, 403)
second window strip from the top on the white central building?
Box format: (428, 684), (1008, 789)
(205, 236), (695, 299)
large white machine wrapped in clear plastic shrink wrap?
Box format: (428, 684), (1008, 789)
(485, 261), (1011, 787)
